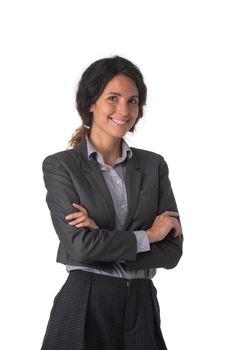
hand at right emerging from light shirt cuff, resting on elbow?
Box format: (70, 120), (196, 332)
(146, 210), (183, 243)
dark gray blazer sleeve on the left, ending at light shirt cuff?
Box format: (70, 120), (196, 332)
(42, 155), (137, 263)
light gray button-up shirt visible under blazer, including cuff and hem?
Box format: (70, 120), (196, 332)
(66, 135), (156, 279)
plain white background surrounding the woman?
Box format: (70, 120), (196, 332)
(0, 0), (233, 350)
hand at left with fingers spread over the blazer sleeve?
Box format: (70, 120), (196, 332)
(65, 203), (99, 228)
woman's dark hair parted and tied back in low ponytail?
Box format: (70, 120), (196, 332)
(68, 56), (147, 148)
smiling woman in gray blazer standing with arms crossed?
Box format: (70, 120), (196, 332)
(42, 56), (183, 350)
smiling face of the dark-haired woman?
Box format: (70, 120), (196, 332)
(90, 75), (139, 138)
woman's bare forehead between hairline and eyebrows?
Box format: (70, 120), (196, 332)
(103, 75), (138, 95)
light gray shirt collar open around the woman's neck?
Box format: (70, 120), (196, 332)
(85, 134), (133, 164)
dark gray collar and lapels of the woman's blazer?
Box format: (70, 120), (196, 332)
(77, 138), (142, 230)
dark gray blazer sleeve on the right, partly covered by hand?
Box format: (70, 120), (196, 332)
(126, 156), (184, 270)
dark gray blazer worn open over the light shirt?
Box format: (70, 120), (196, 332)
(42, 139), (183, 270)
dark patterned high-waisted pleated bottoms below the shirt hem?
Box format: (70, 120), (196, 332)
(41, 270), (167, 350)
